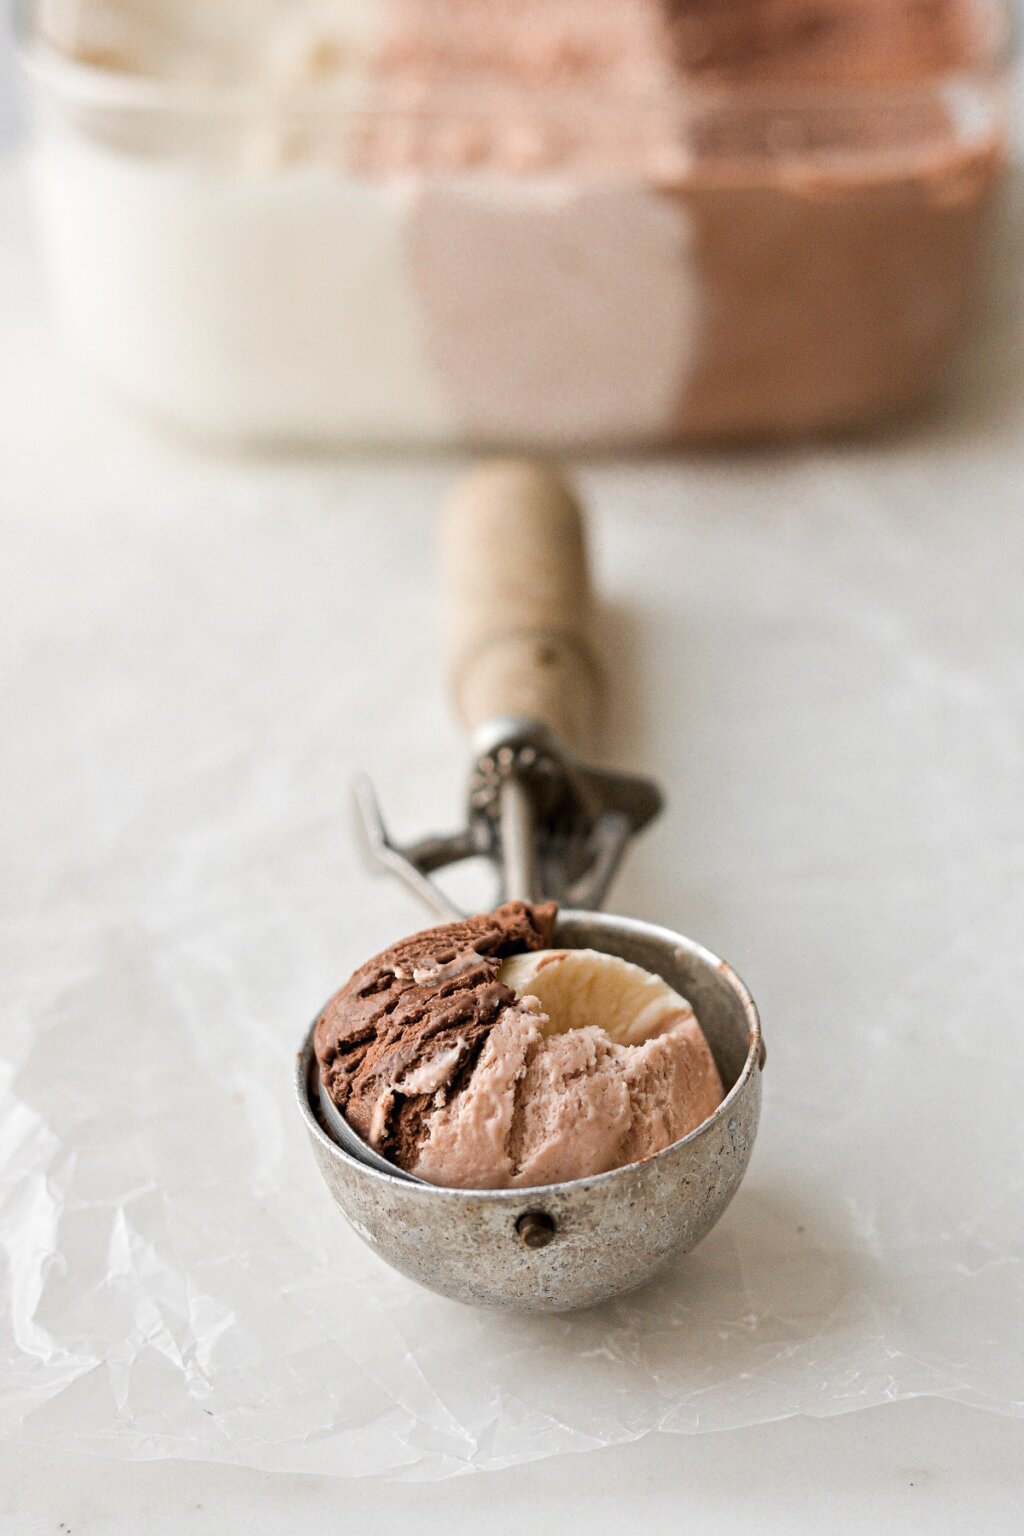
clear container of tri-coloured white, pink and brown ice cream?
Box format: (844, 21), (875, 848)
(20, 0), (1007, 447)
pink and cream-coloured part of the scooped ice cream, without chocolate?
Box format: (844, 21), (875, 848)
(413, 949), (723, 1189)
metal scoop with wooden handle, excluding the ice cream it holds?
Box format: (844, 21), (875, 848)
(296, 462), (765, 1312)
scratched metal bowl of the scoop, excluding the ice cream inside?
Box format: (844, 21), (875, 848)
(296, 911), (765, 1312)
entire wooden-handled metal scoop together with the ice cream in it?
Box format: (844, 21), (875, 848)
(296, 462), (763, 1310)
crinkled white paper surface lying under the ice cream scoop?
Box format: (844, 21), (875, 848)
(0, 158), (1024, 1479)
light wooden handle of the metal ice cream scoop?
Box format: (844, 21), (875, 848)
(441, 459), (600, 751)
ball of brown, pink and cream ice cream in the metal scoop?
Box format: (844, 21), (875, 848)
(316, 902), (723, 1189)
